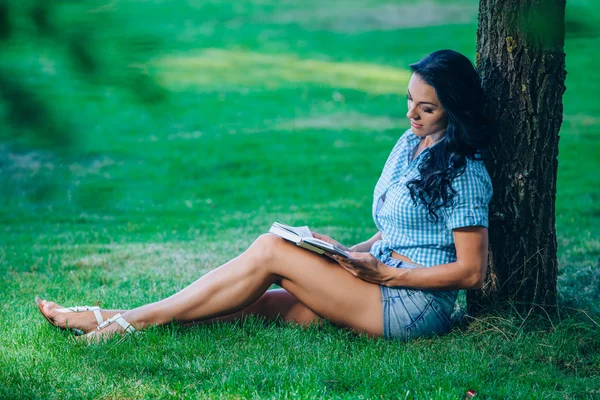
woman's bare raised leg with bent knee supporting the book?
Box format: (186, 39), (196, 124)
(91, 234), (383, 336)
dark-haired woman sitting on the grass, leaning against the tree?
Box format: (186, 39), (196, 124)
(38, 50), (492, 340)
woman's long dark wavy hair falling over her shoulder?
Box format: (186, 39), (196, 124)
(407, 50), (490, 222)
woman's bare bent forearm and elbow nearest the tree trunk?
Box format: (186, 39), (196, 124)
(384, 226), (488, 290)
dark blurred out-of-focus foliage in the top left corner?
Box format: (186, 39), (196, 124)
(0, 0), (166, 150)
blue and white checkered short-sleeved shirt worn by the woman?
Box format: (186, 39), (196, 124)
(370, 129), (492, 267)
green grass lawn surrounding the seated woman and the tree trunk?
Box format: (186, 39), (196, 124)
(0, 0), (600, 399)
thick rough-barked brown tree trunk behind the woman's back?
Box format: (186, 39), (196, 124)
(467, 0), (566, 313)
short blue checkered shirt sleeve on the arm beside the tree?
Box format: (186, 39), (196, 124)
(446, 159), (492, 230)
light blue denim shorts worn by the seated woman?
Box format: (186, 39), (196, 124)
(380, 255), (458, 341)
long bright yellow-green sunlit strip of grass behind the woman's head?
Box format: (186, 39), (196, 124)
(151, 49), (410, 94)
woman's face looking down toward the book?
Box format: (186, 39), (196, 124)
(406, 73), (448, 137)
